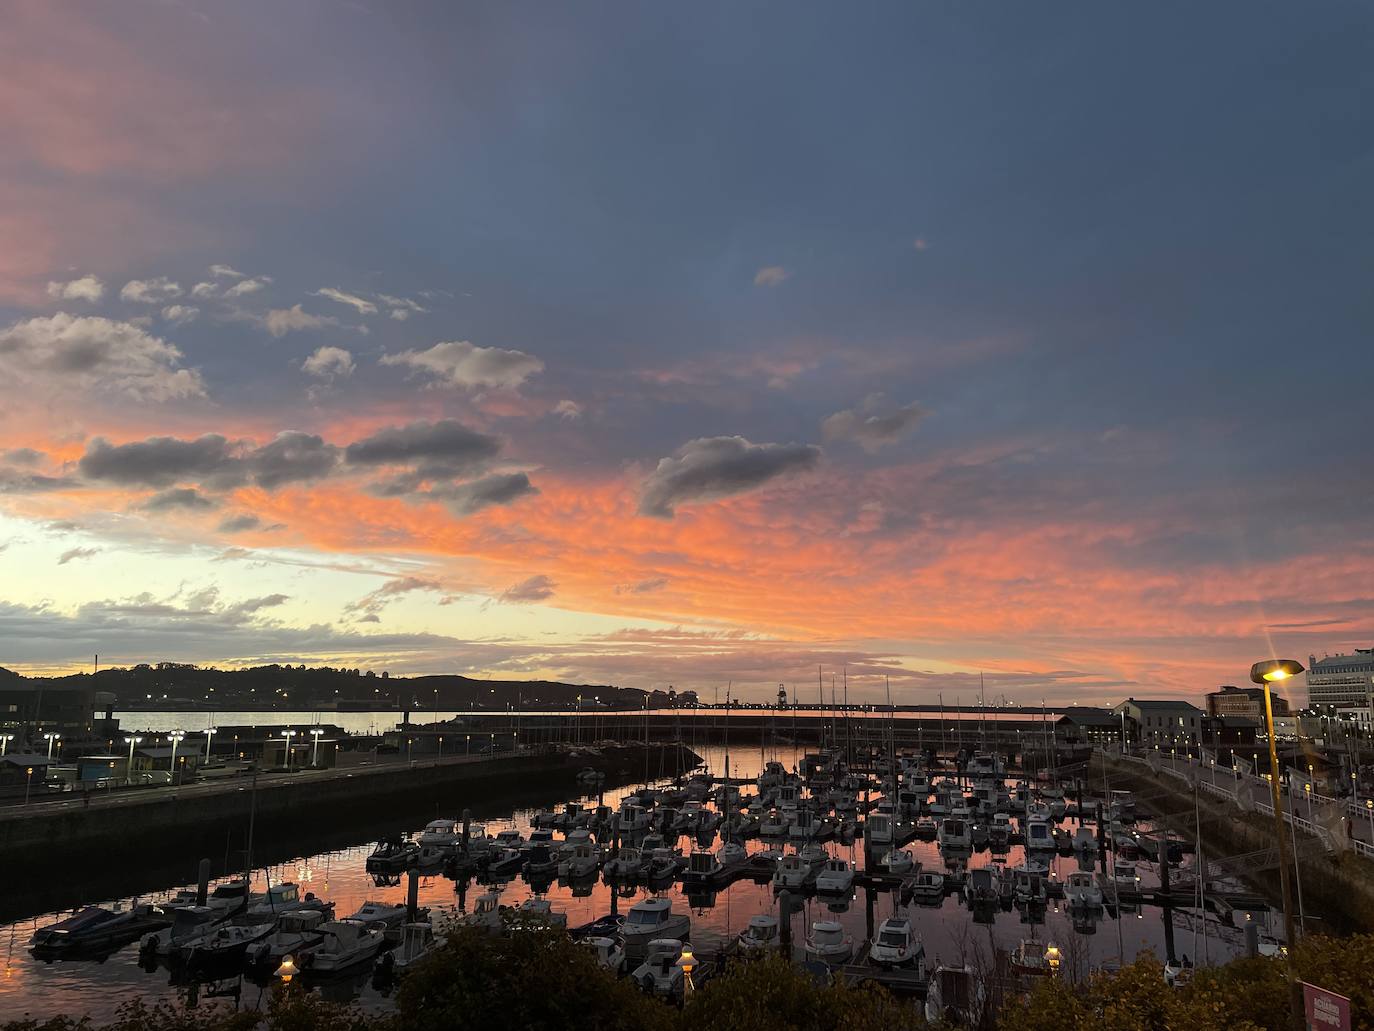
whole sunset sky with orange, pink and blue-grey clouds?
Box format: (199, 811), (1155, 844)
(0, 0), (1374, 704)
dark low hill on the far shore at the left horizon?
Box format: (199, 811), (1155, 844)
(0, 663), (681, 711)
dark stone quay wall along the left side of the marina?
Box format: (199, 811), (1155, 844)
(0, 744), (699, 918)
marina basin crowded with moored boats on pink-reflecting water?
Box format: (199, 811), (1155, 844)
(0, 746), (1274, 1017)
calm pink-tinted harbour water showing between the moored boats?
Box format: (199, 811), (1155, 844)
(0, 753), (1264, 1019)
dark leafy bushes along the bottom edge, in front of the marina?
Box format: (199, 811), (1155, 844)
(10, 928), (1374, 1031)
